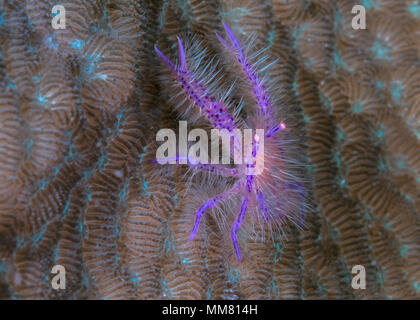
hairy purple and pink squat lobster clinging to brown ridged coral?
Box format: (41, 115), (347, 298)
(155, 23), (305, 260)
